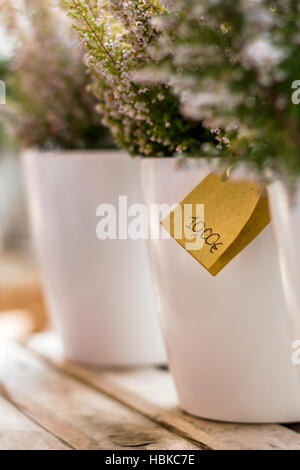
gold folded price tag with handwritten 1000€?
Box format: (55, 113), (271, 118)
(162, 173), (270, 276)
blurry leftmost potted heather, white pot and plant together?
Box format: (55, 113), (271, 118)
(1, 0), (165, 365)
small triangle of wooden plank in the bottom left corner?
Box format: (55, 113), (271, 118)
(0, 397), (71, 450)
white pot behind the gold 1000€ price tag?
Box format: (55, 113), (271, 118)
(141, 158), (300, 423)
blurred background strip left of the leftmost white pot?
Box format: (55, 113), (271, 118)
(0, 20), (48, 339)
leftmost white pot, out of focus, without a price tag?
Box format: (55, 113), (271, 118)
(23, 151), (165, 365)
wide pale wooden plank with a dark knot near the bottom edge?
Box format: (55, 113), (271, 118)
(0, 343), (197, 450)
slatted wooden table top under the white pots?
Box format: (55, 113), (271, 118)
(0, 333), (300, 451)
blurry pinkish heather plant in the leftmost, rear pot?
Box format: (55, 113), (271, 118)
(0, 0), (111, 149)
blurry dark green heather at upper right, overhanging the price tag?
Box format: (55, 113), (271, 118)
(143, 0), (300, 174)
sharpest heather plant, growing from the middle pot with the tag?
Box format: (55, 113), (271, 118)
(65, 0), (214, 157)
